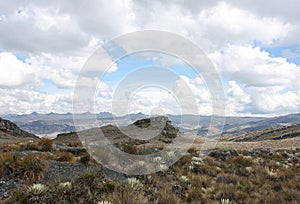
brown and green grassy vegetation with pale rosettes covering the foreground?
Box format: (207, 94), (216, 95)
(0, 140), (300, 204)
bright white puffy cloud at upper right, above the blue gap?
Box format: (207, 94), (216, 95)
(199, 3), (292, 44)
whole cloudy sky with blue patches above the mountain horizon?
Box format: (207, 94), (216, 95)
(0, 0), (300, 116)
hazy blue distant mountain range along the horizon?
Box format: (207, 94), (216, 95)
(3, 112), (300, 137)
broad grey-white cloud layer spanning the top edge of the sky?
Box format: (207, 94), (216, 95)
(0, 0), (300, 53)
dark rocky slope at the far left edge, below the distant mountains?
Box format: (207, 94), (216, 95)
(0, 118), (38, 138)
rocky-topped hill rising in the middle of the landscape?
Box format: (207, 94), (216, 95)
(55, 116), (179, 151)
